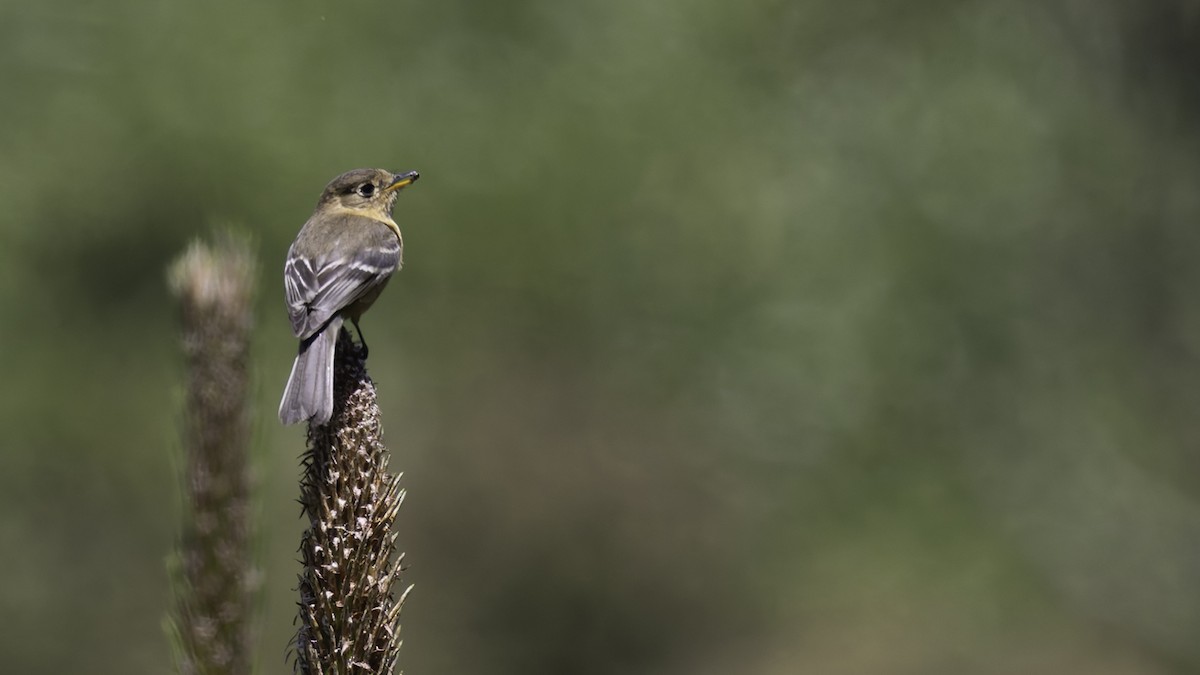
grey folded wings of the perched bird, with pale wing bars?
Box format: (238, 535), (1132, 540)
(283, 222), (401, 340)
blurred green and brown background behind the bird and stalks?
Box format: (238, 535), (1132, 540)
(0, 0), (1200, 675)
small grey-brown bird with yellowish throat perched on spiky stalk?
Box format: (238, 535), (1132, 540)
(280, 168), (420, 424)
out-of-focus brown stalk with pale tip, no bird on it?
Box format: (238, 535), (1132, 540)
(169, 235), (257, 675)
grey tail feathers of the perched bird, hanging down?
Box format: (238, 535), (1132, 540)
(280, 316), (342, 424)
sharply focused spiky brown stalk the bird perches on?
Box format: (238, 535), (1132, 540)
(296, 330), (412, 675)
